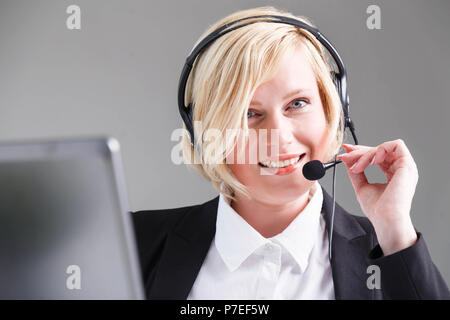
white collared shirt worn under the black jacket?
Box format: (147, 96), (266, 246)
(187, 181), (335, 300)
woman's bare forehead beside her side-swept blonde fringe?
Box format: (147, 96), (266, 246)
(250, 47), (317, 99)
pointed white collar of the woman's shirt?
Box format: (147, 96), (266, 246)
(215, 181), (323, 272)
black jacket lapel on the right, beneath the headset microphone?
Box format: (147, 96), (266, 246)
(322, 187), (375, 300)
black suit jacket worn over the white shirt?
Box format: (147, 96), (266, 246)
(132, 188), (450, 299)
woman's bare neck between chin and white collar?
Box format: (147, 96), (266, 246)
(230, 190), (309, 238)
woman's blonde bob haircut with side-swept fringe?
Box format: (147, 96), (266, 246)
(181, 7), (344, 200)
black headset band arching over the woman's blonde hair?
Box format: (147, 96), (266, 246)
(178, 15), (358, 146)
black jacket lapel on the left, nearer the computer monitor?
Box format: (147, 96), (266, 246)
(147, 196), (219, 300)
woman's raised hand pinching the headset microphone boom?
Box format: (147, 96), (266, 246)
(337, 139), (419, 256)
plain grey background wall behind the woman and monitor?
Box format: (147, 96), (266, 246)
(0, 0), (450, 283)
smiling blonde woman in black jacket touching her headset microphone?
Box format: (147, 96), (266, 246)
(133, 7), (449, 299)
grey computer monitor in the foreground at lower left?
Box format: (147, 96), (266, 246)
(0, 137), (144, 299)
